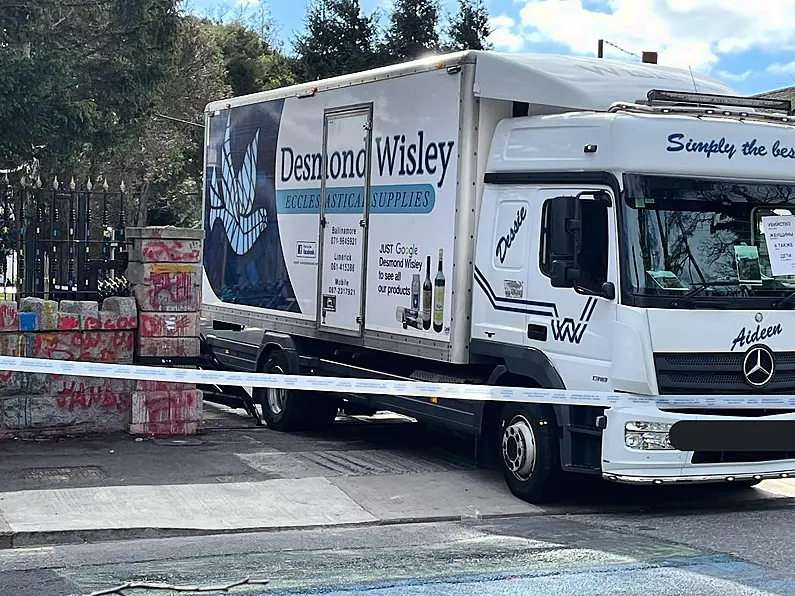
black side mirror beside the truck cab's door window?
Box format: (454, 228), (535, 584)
(547, 197), (582, 288)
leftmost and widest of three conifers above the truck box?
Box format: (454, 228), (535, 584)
(293, 0), (378, 81)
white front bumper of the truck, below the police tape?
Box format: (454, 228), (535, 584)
(602, 407), (795, 484)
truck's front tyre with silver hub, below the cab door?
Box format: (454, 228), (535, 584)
(498, 404), (563, 503)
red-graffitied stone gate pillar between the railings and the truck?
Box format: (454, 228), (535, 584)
(127, 227), (204, 436)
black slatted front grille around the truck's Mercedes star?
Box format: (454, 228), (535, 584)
(654, 352), (795, 395)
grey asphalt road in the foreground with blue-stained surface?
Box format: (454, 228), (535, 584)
(0, 508), (795, 596)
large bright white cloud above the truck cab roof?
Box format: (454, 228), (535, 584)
(494, 0), (795, 72)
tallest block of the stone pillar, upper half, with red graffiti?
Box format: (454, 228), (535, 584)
(128, 263), (202, 312)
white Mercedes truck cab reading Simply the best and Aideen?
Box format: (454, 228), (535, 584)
(472, 91), (795, 494)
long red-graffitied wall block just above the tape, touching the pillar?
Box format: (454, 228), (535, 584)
(29, 331), (135, 364)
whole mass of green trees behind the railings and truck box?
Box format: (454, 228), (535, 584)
(0, 0), (490, 226)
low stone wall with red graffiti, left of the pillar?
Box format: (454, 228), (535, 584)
(0, 298), (138, 438)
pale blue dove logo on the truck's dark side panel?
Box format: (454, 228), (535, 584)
(209, 118), (268, 255)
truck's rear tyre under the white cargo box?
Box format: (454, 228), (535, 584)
(256, 350), (339, 432)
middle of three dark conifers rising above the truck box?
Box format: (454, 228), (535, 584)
(383, 0), (441, 62)
